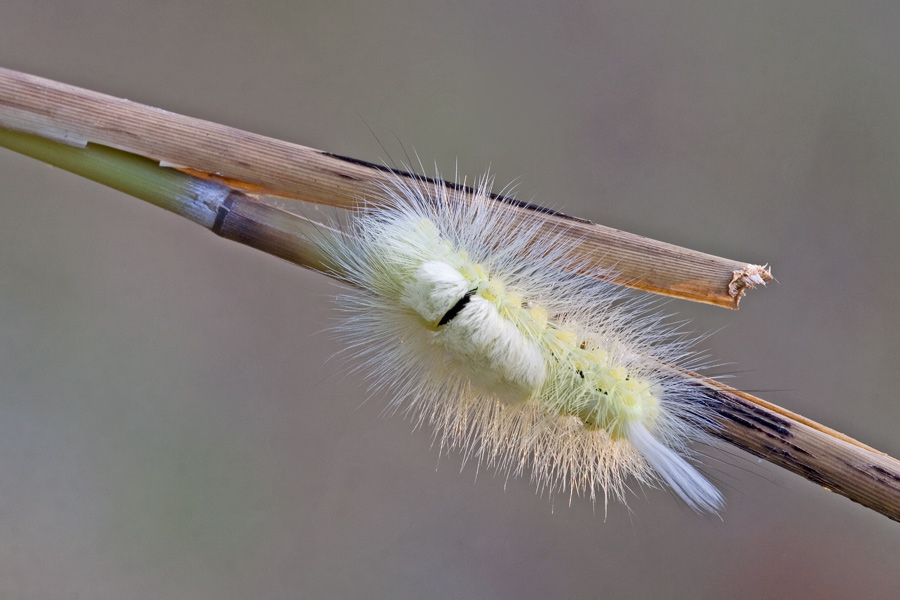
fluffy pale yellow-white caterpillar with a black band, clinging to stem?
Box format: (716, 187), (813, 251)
(320, 171), (724, 512)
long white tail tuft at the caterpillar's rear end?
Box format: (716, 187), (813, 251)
(626, 422), (725, 512)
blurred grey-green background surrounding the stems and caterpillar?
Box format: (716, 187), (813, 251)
(0, 0), (900, 599)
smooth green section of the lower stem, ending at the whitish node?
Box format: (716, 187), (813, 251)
(0, 128), (221, 227)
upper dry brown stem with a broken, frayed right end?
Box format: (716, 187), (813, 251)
(0, 69), (772, 308)
